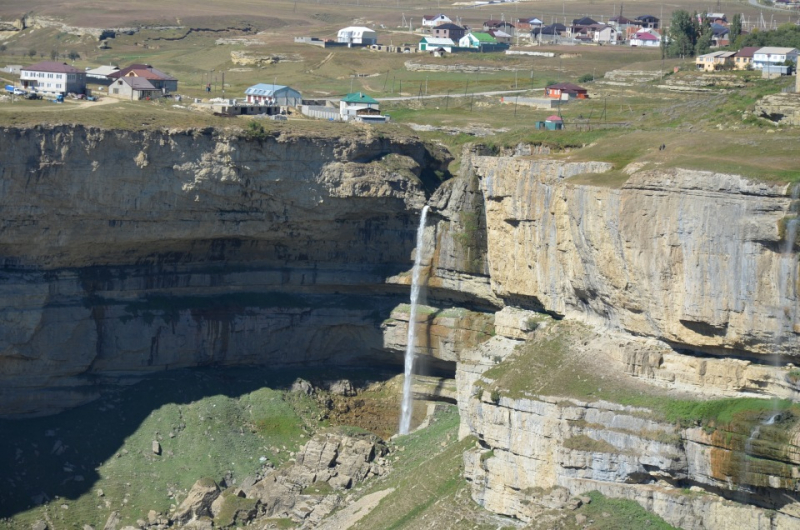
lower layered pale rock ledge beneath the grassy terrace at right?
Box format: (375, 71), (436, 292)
(457, 318), (800, 529)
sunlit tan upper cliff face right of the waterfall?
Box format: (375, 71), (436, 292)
(473, 156), (800, 356)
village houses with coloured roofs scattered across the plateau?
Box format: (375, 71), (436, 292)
(5, 10), (798, 130)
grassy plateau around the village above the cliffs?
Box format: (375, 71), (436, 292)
(0, 0), (800, 186)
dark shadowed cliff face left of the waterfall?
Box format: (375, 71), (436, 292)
(0, 127), (447, 414)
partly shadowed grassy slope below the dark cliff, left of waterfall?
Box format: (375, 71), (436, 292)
(0, 368), (424, 528)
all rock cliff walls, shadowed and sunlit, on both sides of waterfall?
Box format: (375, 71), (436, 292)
(0, 126), (800, 528)
